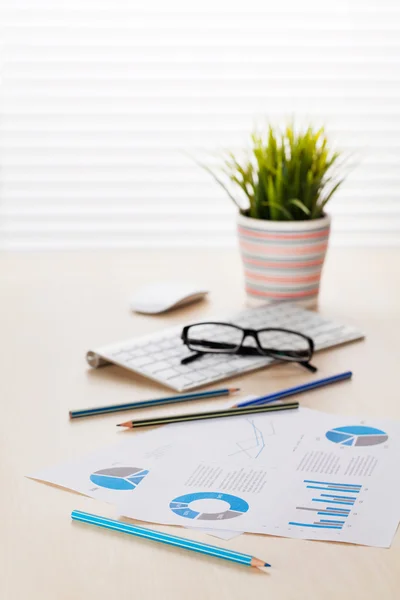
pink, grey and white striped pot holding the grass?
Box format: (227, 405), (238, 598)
(238, 215), (330, 307)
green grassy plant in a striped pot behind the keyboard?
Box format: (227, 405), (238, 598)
(202, 126), (343, 306)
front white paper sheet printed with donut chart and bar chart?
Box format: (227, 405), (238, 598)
(120, 410), (400, 547)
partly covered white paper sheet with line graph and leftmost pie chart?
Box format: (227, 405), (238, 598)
(29, 396), (307, 540)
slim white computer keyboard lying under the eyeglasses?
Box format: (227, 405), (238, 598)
(87, 304), (364, 392)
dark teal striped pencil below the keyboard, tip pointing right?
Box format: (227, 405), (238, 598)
(69, 388), (240, 419)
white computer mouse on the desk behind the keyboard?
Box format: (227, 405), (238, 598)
(131, 281), (208, 315)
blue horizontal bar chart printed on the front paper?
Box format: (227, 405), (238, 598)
(289, 479), (362, 530)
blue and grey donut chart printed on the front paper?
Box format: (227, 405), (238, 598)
(169, 492), (249, 521)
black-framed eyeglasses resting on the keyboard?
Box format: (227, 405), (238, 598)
(181, 321), (317, 373)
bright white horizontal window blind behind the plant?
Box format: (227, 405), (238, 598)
(0, 0), (400, 249)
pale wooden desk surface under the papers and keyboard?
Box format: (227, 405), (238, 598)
(0, 249), (400, 600)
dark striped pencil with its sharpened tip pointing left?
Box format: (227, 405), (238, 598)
(117, 402), (299, 429)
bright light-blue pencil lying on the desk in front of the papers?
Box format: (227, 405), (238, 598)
(71, 510), (271, 567)
